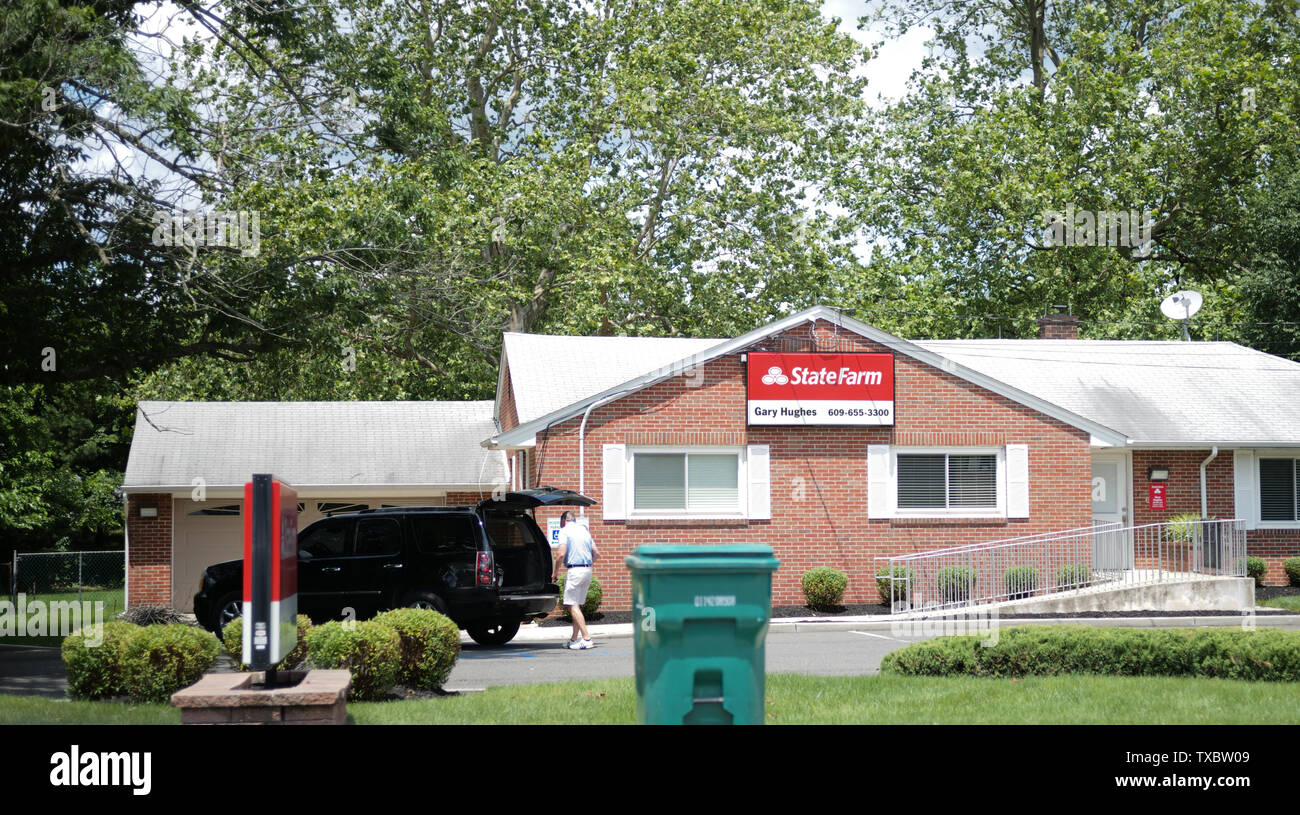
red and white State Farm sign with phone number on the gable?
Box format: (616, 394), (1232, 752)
(746, 352), (893, 425)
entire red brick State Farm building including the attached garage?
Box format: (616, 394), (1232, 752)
(124, 307), (1300, 610)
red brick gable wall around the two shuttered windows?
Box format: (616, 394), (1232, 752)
(530, 318), (1092, 610)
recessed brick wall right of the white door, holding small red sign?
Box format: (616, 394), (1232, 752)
(1132, 447), (1300, 586)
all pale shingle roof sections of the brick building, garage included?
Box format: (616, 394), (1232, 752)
(124, 323), (1300, 489)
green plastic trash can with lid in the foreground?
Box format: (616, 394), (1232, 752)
(625, 545), (780, 724)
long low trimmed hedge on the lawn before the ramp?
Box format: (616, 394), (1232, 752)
(880, 625), (1300, 681)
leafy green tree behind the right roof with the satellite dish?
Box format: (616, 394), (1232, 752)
(852, 0), (1300, 338)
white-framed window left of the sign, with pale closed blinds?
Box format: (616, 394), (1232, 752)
(631, 450), (744, 515)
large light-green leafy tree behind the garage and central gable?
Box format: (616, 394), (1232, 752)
(144, 0), (867, 396)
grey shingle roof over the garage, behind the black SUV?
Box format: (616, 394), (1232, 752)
(122, 402), (504, 489)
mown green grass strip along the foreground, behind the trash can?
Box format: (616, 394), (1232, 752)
(0, 673), (1300, 724)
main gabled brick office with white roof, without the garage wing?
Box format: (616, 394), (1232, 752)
(489, 307), (1300, 608)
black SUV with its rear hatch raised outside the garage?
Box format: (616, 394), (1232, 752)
(194, 487), (595, 645)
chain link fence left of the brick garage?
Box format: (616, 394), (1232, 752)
(7, 550), (126, 615)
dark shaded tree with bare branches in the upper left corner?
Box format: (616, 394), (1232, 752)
(0, 0), (330, 385)
